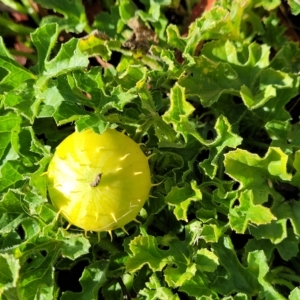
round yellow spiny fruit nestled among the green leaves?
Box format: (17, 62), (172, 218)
(47, 129), (152, 236)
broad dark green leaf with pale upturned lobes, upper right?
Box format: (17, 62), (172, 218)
(179, 40), (271, 109)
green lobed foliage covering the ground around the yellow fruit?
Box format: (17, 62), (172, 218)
(0, 0), (300, 300)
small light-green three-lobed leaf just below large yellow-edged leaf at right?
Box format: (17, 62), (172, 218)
(229, 190), (276, 233)
